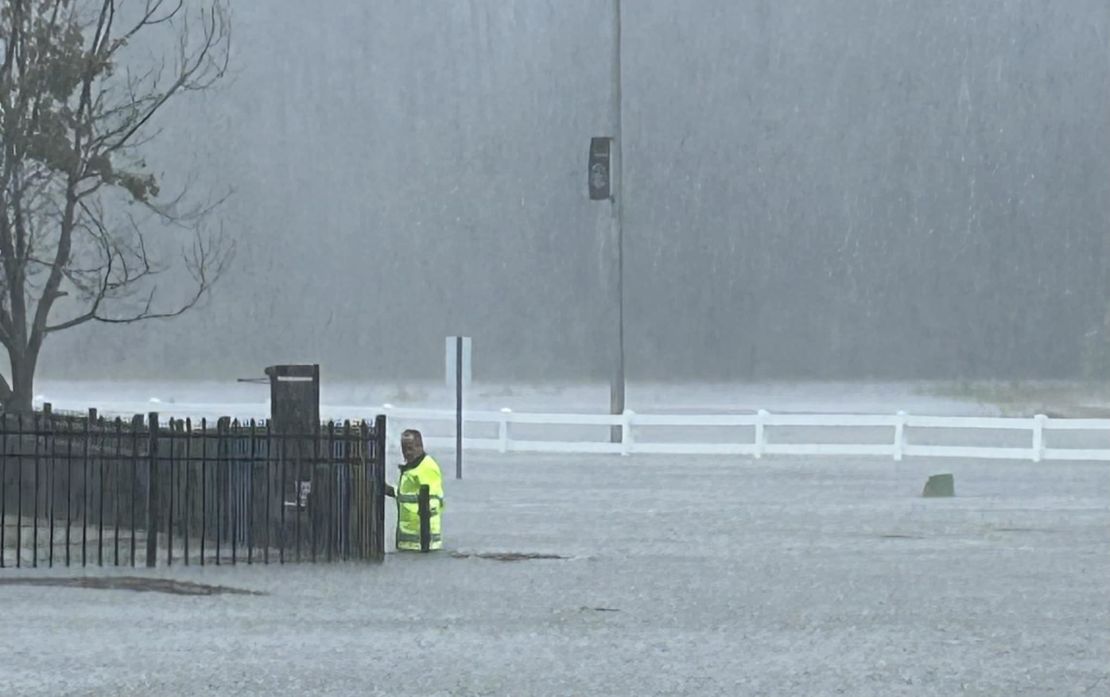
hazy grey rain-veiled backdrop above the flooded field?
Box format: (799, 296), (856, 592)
(42, 0), (1110, 380)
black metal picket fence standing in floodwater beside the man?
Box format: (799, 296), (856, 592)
(0, 411), (385, 567)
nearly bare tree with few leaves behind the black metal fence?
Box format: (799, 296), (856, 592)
(0, 0), (232, 411)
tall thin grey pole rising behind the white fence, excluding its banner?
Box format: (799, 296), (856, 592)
(609, 0), (625, 443)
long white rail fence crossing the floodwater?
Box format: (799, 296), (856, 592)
(382, 404), (1110, 462)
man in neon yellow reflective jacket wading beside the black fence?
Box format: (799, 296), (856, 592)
(385, 430), (443, 552)
